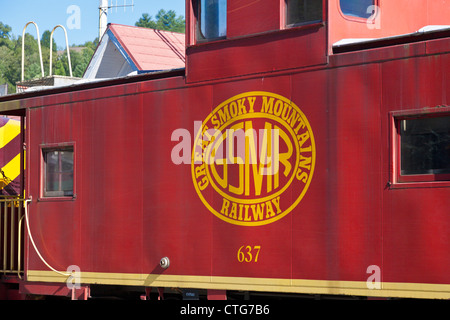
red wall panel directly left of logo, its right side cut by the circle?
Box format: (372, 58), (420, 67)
(142, 87), (212, 275)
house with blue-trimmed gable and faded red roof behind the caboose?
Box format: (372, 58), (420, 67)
(83, 23), (185, 79)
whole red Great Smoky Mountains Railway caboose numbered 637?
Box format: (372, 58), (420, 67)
(0, 0), (450, 299)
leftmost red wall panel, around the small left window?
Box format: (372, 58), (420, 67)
(27, 105), (79, 270)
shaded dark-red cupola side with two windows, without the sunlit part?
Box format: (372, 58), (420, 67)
(186, 0), (327, 82)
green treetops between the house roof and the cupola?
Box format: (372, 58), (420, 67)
(135, 9), (186, 33)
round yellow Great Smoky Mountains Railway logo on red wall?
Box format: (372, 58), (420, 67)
(191, 91), (316, 226)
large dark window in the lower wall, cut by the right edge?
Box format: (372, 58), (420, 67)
(397, 115), (450, 182)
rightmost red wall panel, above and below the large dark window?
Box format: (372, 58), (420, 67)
(381, 54), (450, 284)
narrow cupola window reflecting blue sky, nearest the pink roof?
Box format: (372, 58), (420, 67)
(197, 0), (227, 41)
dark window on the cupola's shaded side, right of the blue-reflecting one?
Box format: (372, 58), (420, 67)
(286, 0), (323, 26)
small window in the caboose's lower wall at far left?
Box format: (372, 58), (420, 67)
(42, 147), (73, 197)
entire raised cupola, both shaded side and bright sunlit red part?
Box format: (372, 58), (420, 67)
(186, 0), (450, 82)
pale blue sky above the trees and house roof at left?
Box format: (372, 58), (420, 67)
(0, 0), (185, 49)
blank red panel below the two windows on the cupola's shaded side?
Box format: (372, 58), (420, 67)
(186, 25), (327, 82)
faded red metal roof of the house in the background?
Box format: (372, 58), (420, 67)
(108, 23), (185, 70)
